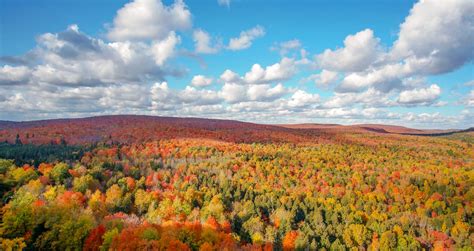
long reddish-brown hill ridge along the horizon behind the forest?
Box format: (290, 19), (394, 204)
(0, 115), (466, 144)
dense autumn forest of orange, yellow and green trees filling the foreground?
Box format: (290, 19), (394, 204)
(0, 116), (474, 250)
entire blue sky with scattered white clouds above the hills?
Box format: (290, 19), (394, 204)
(0, 0), (474, 129)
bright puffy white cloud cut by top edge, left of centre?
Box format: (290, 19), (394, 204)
(107, 0), (192, 41)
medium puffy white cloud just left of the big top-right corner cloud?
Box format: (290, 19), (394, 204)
(316, 29), (381, 72)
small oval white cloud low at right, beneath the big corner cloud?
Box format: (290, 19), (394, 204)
(398, 84), (441, 105)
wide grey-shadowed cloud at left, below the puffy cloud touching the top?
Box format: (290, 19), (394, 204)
(0, 25), (180, 86)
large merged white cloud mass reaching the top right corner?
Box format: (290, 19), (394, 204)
(330, 0), (474, 92)
